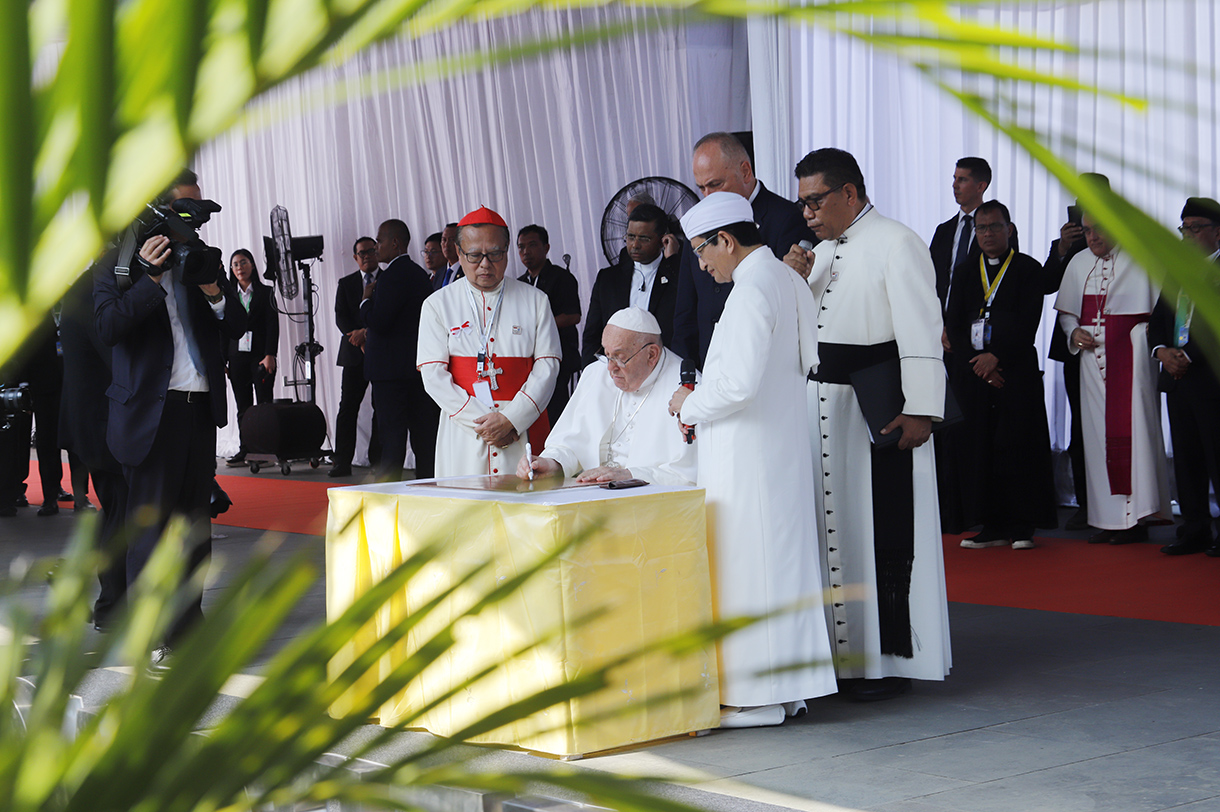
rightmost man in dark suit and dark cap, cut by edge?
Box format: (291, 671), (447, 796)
(1148, 198), (1220, 556)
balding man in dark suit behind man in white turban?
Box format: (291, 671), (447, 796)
(673, 133), (817, 369)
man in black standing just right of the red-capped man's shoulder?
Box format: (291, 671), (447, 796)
(517, 223), (581, 426)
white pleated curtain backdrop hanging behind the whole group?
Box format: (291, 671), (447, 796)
(196, 0), (1220, 480)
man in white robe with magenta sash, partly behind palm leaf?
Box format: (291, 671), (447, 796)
(1055, 215), (1172, 544)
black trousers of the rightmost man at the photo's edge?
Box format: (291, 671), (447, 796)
(1165, 385), (1220, 532)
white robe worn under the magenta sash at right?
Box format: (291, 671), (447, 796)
(1055, 249), (1172, 530)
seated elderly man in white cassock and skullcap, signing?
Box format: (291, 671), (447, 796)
(517, 307), (697, 485)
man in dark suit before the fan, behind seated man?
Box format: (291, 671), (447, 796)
(581, 204), (678, 368)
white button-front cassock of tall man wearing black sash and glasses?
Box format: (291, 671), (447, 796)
(808, 207), (953, 679)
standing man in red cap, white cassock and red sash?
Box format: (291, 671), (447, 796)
(416, 207), (561, 477)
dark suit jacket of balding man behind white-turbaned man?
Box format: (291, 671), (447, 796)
(673, 180), (817, 369)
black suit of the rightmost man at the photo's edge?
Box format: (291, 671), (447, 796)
(1148, 280), (1220, 543)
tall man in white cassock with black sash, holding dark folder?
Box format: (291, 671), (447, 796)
(786, 149), (952, 701)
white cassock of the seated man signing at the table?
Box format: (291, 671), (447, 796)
(540, 347), (697, 485)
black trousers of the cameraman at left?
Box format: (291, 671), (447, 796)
(123, 393), (216, 646)
